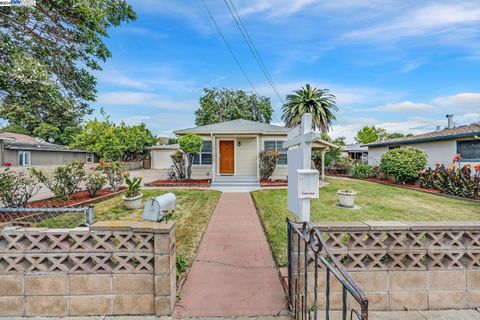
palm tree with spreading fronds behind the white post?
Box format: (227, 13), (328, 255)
(282, 84), (338, 132)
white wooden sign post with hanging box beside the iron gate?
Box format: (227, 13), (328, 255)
(286, 113), (320, 221)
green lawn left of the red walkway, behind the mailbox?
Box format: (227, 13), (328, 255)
(41, 189), (220, 267)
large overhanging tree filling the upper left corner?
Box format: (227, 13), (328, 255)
(0, 0), (136, 144)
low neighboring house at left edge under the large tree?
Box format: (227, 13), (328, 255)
(0, 132), (97, 167)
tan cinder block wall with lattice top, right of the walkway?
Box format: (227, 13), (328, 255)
(291, 221), (480, 310)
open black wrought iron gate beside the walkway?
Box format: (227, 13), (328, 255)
(287, 219), (368, 320)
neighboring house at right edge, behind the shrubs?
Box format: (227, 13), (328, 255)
(366, 115), (480, 168)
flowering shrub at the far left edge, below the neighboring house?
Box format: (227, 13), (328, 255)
(0, 169), (40, 208)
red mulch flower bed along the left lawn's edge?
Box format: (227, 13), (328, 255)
(27, 187), (126, 208)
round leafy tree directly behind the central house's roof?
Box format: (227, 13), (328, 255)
(195, 88), (273, 126)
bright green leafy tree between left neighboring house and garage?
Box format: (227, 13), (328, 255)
(71, 119), (156, 161)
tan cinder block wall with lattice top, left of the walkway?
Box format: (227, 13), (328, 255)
(0, 221), (176, 316)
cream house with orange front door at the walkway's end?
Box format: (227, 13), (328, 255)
(150, 119), (335, 185)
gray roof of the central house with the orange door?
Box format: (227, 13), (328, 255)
(174, 119), (290, 135)
